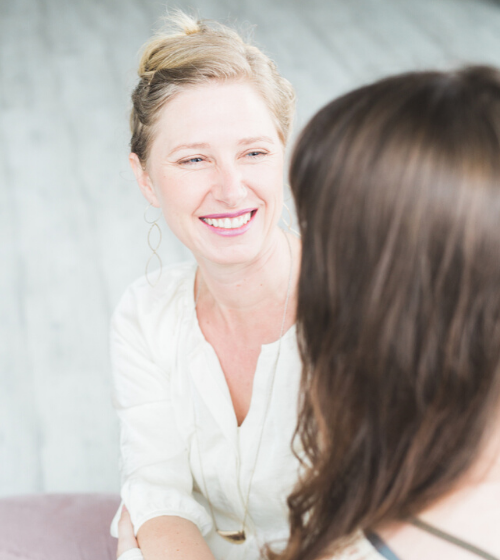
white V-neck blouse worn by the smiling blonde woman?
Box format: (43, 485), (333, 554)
(111, 263), (301, 560)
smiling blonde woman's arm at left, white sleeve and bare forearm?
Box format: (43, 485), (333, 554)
(111, 284), (213, 560)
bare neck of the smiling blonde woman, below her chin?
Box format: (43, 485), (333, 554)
(195, 228), (300, 330)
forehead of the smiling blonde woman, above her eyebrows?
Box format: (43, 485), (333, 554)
(153, 82), (279, 149)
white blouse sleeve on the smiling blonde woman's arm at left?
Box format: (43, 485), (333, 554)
(110, 289), (212, 537)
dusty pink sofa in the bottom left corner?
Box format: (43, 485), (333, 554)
(0, 494), (120, 560)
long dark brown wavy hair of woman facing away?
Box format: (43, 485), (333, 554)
(275, 67), (500, 560)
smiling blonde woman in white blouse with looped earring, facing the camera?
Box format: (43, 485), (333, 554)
(111, 13), (300, 560)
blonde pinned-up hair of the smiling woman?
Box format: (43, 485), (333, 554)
(130, 11), (295, 165)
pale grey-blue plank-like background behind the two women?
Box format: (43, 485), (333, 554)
(0, 0), (500, 495)
